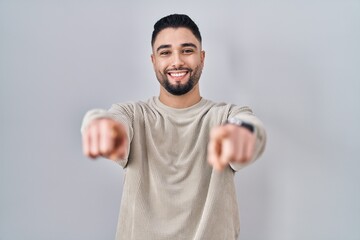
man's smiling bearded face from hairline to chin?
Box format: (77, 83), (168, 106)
(151, 27), (205, 95)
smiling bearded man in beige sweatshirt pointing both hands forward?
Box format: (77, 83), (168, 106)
(82, 14), (265, 240)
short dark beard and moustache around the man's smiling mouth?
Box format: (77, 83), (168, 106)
(156, 66), (202, 96)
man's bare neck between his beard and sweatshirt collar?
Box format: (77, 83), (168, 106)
(159, 84), (201, 108)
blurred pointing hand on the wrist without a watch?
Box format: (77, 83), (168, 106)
(82, 118), (128, 160)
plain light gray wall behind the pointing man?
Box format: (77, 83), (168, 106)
(0, 0), (360, 240)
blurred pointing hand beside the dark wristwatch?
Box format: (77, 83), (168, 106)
(208, 124), (256, 170)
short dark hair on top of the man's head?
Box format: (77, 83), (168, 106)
(151, 14), (201, 46)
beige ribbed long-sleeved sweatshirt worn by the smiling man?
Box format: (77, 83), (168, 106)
(82, 97), (266, 240)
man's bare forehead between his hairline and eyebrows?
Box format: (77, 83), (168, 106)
(154, 27), (200, 49)
